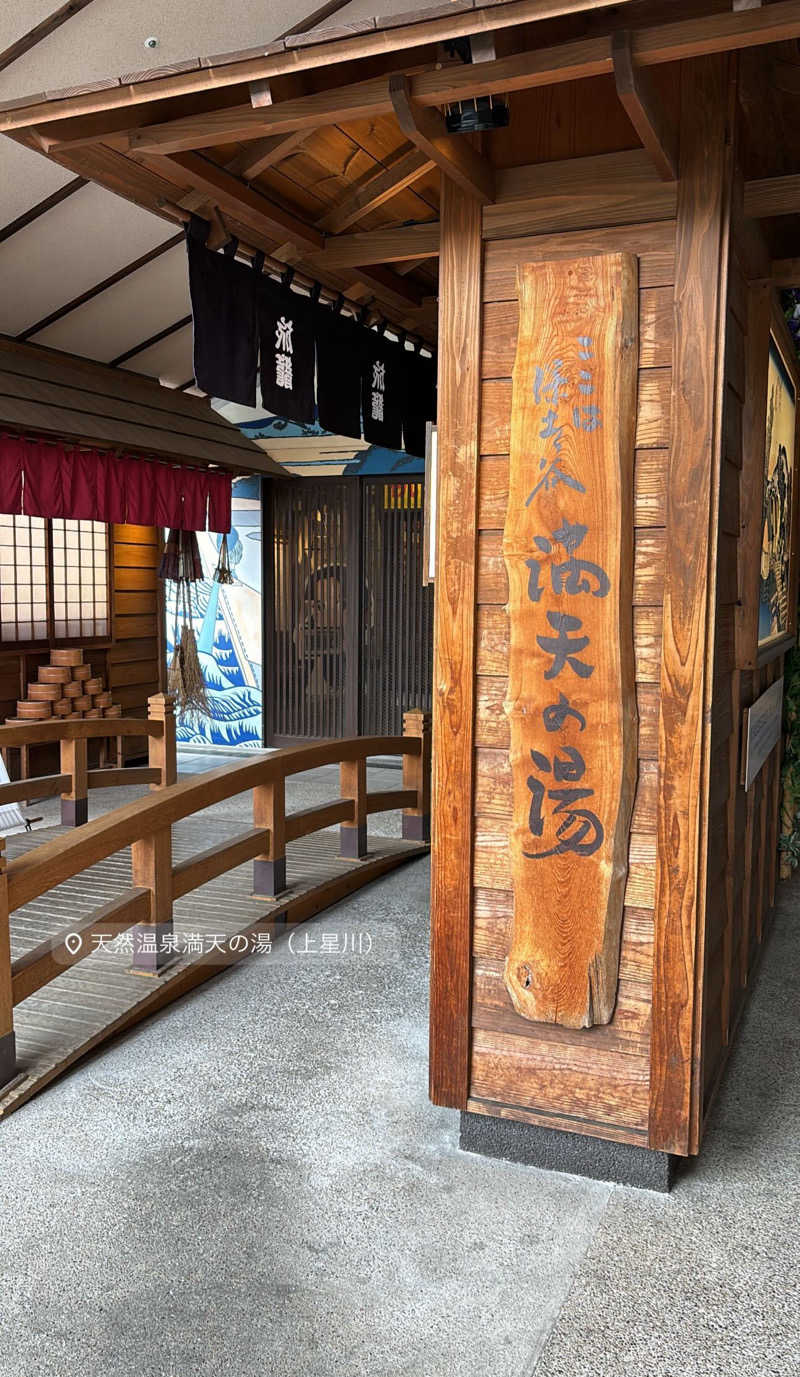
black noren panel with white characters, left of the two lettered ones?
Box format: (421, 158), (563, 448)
(257, 275), (315, 425)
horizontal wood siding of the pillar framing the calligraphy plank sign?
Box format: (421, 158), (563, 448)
(470, 214), (675, 1143)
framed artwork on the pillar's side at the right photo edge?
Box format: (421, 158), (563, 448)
(757, 321), (797, 660)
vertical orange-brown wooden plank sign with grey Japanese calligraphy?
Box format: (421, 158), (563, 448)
(503, 253), (638, 1027)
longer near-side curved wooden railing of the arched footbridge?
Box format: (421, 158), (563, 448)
(0, 700), (431, 1086)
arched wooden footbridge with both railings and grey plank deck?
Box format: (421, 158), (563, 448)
(0, 695), (430, 1117)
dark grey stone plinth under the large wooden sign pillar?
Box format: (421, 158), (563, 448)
(459, 1113), (677, 1192)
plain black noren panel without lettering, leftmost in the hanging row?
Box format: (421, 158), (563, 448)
(186, 215), (257, 406)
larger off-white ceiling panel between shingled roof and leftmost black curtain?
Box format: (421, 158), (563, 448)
(32, 233), (191, 360)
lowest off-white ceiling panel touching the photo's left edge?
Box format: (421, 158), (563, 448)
(0, 186), (175, 335)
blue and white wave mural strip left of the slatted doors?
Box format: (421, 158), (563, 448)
(165, 478), (263, 749)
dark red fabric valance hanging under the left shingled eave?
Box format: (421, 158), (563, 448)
(0, 435), (231, 533)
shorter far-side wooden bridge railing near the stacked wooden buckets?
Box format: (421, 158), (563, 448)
(0, 693), (178, 828)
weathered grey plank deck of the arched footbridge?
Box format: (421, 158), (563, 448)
(0, 815), (428, 1118)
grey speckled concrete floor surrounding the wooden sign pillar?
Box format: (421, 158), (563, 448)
(0, 757), (800, 1377)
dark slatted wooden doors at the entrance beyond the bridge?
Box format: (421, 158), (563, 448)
(264, 478), (432, 745)
